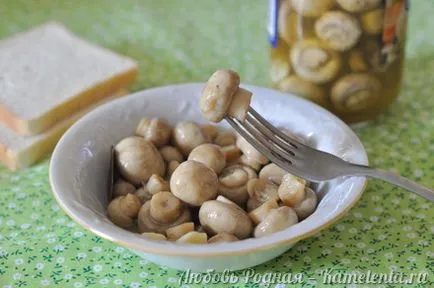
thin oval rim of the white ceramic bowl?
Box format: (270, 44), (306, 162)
(49, 82), (368, 257)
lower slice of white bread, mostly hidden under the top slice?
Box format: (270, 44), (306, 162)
(0, 90), (128, 171)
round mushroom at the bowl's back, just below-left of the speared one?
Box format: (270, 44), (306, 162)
(173, 121), (209, 157)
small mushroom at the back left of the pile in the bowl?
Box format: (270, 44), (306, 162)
(136, 118), (172, 148)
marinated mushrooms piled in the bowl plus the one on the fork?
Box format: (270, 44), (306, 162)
(107, 70), (318, 244)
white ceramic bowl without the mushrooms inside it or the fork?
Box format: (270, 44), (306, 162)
(50, 83), (368, 271)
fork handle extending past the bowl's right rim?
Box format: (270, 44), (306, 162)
(348, 164), (434, 202)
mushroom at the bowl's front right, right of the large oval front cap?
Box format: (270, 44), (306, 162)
(254, 206), (298, 238)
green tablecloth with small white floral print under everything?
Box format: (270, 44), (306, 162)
(0, 0), (434, 287)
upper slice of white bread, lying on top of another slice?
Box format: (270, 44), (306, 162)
(0, 22), (138, 135)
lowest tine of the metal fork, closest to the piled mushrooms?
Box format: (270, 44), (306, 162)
(226, 117), (295, 174)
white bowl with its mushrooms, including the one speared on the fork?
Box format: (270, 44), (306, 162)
(50, 71), (367, 271)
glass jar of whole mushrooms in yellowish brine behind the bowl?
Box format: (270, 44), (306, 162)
(268, 0), (408, 123)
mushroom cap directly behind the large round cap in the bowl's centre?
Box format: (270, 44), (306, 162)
(188, 144), (226, 174)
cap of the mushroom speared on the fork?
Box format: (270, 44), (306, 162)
(199, 70), (240, 122)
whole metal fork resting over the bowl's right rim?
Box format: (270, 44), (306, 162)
(225, 107), (434, 202)
